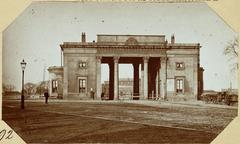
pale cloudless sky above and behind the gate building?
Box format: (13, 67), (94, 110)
(3, 2), (237, 90)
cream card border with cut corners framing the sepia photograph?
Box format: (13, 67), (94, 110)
(0, 0), (240, 144)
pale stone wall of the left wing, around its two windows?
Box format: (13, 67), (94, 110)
(64, 48), (96, 99)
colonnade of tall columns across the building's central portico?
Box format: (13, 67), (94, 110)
(96, 57), (167, 100)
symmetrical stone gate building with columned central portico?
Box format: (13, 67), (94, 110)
(49, 33), (203, 100)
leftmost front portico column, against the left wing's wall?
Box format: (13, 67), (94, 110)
(96, 56), (102, 99)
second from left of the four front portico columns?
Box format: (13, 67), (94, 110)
(113, 57), (119, 100)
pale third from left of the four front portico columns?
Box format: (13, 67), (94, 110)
(143, 57), (149, 99)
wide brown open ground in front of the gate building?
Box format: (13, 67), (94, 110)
(3, 100), (237, 143)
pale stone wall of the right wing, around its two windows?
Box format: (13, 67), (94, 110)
(167, 49), (198, 99)
